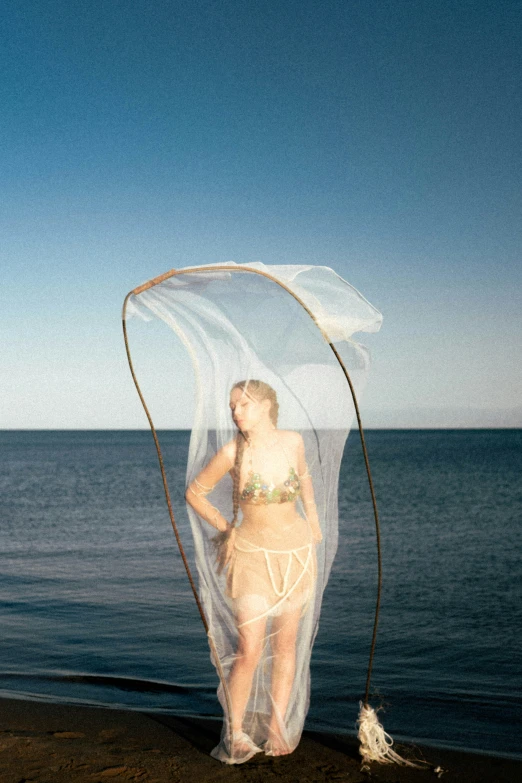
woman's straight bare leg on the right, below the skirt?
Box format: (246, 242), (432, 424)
(269, 606), (302, 756)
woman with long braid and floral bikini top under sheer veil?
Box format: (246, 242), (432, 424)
(186, 380), (322, 763)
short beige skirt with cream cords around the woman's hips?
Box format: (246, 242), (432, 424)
(226, 535), (317, 627)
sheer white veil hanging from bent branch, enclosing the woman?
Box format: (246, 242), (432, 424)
(126, 262), (382, 763)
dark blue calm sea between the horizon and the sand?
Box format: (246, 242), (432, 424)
(0, 430), (522, 758)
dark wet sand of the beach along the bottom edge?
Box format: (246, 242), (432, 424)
(0, 699), (522, 783)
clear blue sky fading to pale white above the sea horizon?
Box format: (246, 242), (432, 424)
(0, 0), (522, 428)
